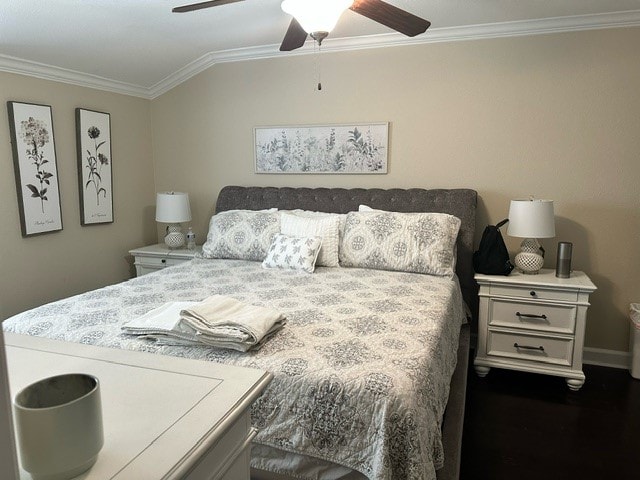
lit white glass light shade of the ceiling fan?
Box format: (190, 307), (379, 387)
(281, 0), (353, 33)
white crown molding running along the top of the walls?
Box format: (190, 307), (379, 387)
(0, 10), (640, 100)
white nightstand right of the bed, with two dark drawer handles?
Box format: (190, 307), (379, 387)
(474, 269), (596, 390)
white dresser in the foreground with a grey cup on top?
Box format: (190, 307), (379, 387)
(5, 333), (271, 480)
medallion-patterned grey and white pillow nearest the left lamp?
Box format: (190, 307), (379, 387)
(202, 210), (280, 262)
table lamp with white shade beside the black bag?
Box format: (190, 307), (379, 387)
(507, 199), (556, 274)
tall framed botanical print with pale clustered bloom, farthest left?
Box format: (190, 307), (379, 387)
(7, 101), (62, 237)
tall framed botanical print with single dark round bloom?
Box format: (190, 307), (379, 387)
(76, 108), (113, 225)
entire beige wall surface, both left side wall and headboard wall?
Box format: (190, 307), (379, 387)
(0, 28), (640, 350)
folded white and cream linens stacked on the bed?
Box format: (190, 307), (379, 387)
(122, 295), (286, 352)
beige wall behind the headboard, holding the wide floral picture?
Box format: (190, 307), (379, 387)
(152, 28), (640, 350)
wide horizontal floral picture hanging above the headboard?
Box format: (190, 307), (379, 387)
(254, 123), (389, 173)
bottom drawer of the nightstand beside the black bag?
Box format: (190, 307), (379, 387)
(487, 331), (573, 366)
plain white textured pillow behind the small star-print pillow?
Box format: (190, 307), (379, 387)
(280, 211), (340, 267)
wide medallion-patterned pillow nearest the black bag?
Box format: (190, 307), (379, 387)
(340, 211), (461, 276)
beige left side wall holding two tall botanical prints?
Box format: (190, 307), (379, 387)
(0, 73), (156, 319)
